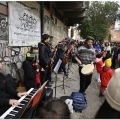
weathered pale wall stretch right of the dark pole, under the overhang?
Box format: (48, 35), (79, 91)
(44, 9), (68, 44)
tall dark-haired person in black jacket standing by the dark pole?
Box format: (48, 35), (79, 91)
(38, 34), (50, 86)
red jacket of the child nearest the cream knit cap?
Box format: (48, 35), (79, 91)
(100, 66), (114, 86)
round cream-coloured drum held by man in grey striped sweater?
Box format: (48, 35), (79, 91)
(81, 64), (94, 75)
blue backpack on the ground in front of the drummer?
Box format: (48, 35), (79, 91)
(70, 92), (87, 112)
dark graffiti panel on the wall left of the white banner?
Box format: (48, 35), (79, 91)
(0, 14), (8, 40)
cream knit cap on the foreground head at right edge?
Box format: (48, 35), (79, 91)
(105, 68), (120, 112)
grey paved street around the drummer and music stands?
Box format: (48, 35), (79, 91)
(52, 63), (104, 119)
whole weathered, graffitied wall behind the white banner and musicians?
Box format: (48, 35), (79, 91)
(0, 1), (68, 78)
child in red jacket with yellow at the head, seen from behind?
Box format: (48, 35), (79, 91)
(99, 54), (114, 97)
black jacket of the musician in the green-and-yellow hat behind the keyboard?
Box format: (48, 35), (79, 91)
(22, 61), (37, 90)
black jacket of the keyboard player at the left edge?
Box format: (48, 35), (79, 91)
(0, 73), (18, 106)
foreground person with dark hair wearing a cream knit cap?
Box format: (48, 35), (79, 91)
(94, 68), (120, 119)
